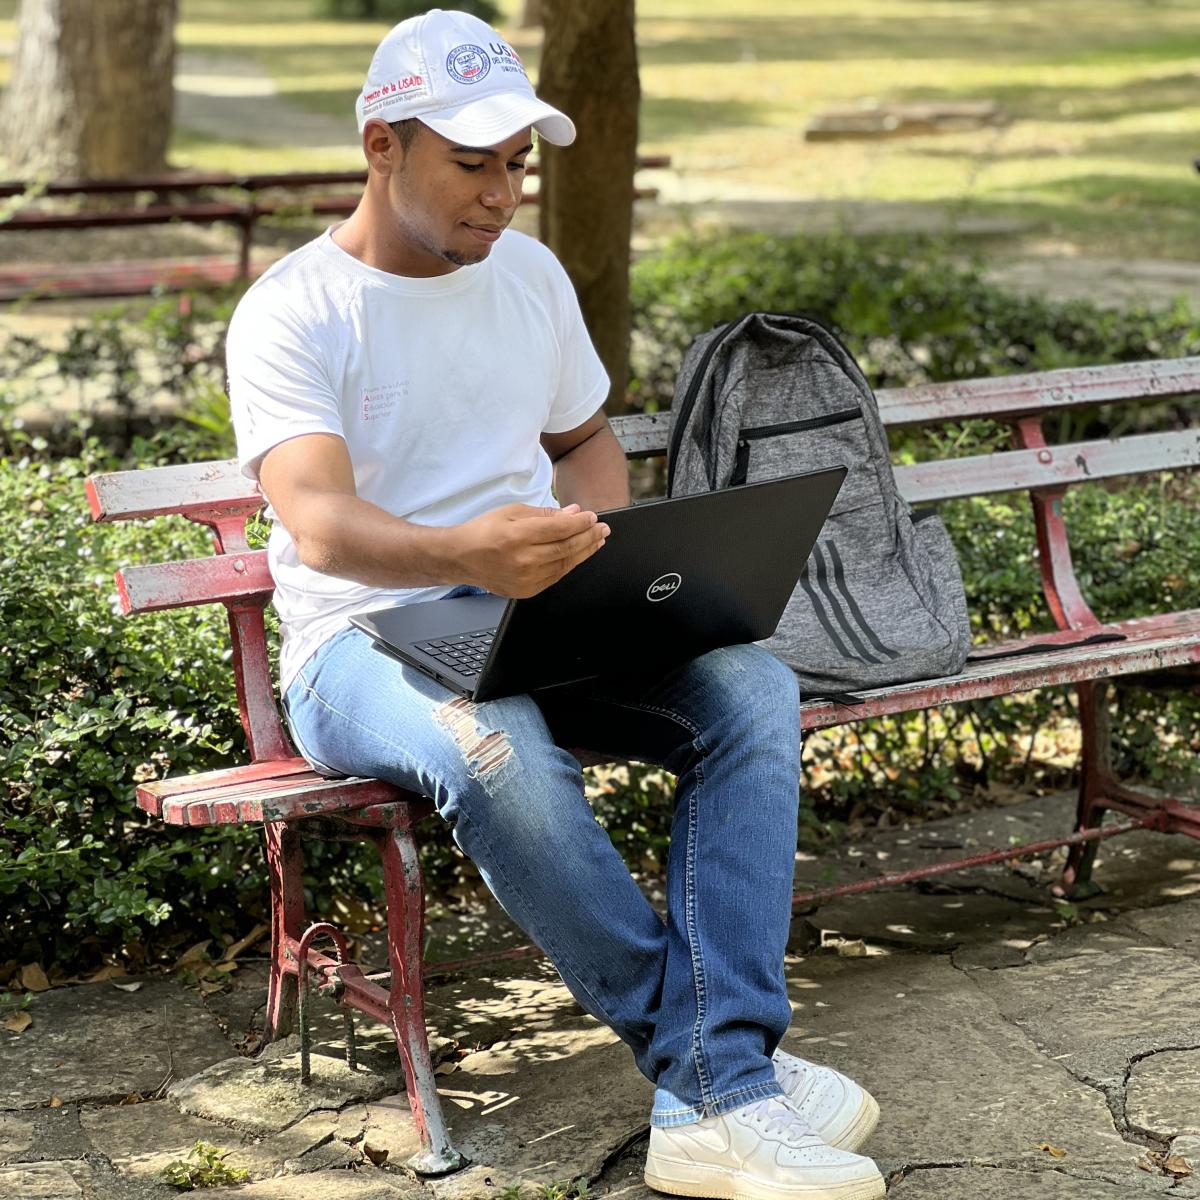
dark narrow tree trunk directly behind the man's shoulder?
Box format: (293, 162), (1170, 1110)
(538, 0), (640, 413)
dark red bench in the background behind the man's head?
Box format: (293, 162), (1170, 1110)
(0, 155), (671, 302)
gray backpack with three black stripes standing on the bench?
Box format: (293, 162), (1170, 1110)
(667, 312), (971, 698)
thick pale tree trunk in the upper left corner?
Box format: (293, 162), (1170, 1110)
(0, 0), (176, 179)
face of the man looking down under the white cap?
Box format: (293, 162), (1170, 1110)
(388, 125), (533, 276)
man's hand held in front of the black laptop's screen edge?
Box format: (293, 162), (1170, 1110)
(454, 504), (610, 600)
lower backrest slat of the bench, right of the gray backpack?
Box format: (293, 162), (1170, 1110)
(895, 428), (1200, 504)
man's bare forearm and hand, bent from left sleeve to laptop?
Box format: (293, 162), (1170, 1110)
(259, 433), (608, 596)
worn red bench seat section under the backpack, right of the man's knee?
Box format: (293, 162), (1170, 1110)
(800, 608), (1200, 730)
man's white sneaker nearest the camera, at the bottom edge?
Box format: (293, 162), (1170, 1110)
(646, 1096), (884, 1200)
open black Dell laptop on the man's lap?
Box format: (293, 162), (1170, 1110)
(350, 467), (846, 701)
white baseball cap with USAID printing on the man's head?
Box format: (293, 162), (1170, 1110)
(354, 8), (575, 146)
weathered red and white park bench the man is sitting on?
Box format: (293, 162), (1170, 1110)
(86, 358), (1200, 1174)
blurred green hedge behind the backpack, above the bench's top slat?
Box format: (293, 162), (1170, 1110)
(630, 233), (1200, 410)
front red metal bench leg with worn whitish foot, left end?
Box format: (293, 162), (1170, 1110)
(378, 824), (467, 1175)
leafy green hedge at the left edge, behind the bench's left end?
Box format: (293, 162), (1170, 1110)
(0, 448), (262, 964)
